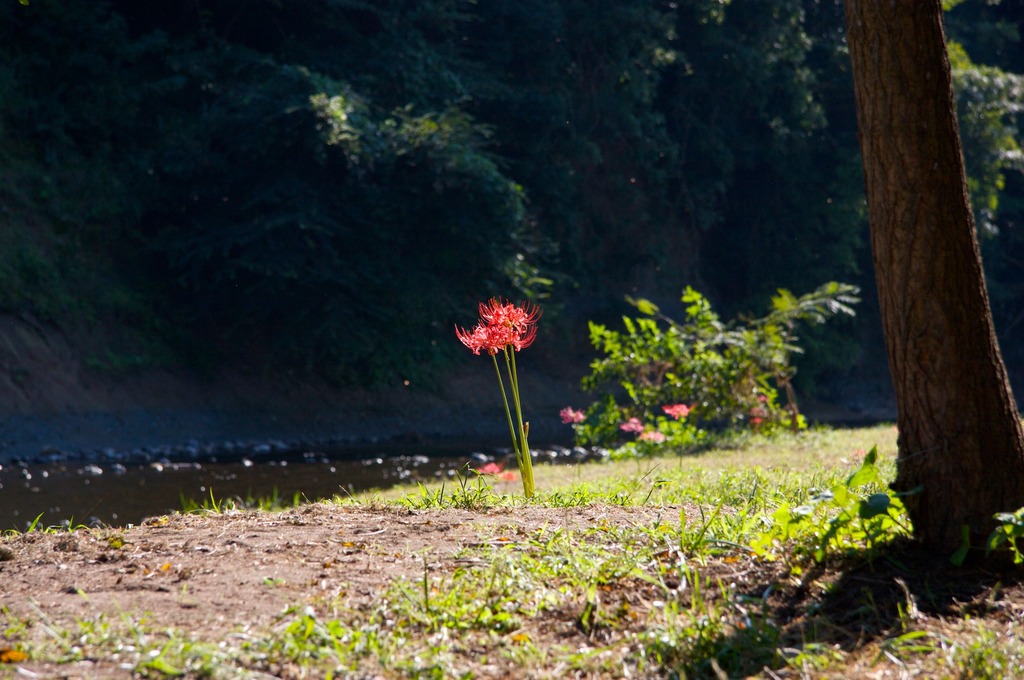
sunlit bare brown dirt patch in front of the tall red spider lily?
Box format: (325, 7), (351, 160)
(0, 504), (692, 678)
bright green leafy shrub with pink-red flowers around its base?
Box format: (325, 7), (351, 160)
(574, 282), (858, 445)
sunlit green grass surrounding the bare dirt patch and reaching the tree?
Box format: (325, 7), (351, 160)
(8, 427), (1024, 678)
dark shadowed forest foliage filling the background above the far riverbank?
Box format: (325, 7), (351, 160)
(0, 0), (1024, 396)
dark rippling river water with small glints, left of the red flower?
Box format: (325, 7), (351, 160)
(0, 448), (503, 530)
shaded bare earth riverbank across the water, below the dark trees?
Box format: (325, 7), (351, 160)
(0, 314), (895, 464)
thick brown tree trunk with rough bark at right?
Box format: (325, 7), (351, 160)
(846, 0), (1024, 554)
